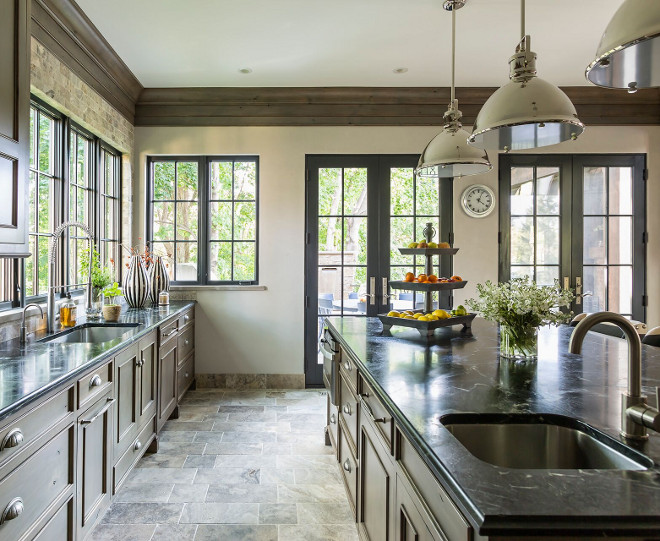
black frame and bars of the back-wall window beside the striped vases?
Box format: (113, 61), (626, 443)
(145, 154), (260, 287)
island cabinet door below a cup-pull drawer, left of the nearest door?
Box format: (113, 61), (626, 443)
(358, 422), (395, 541)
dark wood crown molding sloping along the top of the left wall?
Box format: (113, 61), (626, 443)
(32, 0), (143, 123)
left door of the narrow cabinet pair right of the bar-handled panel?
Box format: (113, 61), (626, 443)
(114, 345), (140, 458)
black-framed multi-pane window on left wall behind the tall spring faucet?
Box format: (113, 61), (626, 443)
(21, 99), (121, 308)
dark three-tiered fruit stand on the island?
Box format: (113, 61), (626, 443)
(378, 223), (477, 338)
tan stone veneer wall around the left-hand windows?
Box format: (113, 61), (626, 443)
(0, 37), (134, 342)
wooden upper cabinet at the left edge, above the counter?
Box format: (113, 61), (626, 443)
(0, 0), (30, 257)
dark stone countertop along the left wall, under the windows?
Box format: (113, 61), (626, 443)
(0, 301), (195, 423)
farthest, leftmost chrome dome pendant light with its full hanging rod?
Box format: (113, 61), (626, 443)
(415, 0), (493, 178)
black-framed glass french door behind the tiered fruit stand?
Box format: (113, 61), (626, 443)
(305, 155), (452, 387)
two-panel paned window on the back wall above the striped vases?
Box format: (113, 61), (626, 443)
(147, 157), (259, 285)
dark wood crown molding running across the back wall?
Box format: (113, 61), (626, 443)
(135, 86), (660, 126)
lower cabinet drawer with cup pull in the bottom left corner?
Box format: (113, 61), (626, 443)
(0, 425), (75, 539)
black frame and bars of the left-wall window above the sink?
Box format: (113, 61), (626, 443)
(20, 95), (123, 310)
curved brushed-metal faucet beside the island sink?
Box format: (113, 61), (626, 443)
(568, 312), (660, 440)
